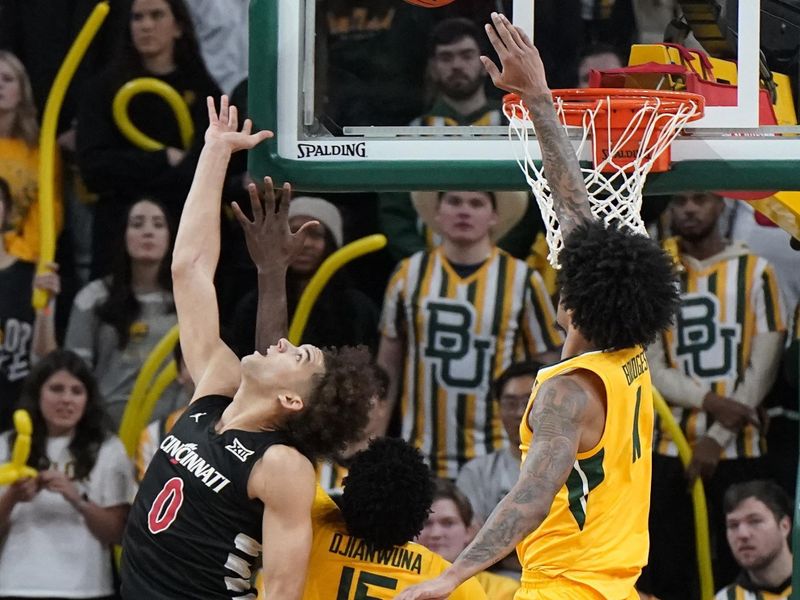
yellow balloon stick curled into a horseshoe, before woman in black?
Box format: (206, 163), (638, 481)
(111, 77), (194, 152)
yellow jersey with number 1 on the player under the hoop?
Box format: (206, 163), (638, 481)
(517, 347), (653, 598)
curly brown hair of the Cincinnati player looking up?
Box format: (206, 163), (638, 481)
(284, 346), (380, 460)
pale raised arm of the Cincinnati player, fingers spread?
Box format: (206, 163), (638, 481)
(172, 96), (272, 382)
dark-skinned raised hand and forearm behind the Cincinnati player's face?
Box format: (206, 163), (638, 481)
(231, 177), (319, 354)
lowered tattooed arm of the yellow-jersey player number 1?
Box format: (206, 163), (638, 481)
(397, 374), (594, 600)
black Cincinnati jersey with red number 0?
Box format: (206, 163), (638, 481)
(121, 396), (291, 600)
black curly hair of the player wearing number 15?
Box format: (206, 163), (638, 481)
(341, 438), (433, 550)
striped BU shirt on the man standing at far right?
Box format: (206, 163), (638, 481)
(654, 244), (786, 459)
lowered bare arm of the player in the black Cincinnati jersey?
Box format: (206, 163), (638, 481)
(256, 446), (316, 600)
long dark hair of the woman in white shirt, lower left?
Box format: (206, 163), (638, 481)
(9, 350), (108, 481)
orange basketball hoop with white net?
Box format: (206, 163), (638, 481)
(503, 88), (705, 269)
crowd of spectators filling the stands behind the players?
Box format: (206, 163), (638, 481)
(0, 0), (800, 600)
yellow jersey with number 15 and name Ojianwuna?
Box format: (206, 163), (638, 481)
(303, 487), (486, 600)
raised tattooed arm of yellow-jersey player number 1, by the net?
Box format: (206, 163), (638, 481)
(481, 13), (594, 237)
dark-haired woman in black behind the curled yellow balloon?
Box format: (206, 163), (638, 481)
(77, 0), (220, 276)
